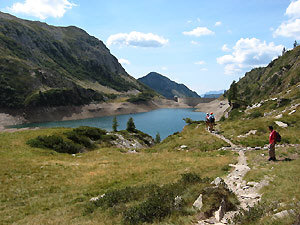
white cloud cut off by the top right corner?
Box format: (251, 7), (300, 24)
(273, 0), (300, 39)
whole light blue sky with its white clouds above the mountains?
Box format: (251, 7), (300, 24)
(0, 0), (300, 94)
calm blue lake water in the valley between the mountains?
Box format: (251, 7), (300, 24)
(14, 108), (205, 139)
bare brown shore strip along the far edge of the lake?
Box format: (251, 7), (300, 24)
(0, 99), (229, 132)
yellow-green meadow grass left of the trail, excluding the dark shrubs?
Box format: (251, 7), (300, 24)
(0, 126), (235, 225)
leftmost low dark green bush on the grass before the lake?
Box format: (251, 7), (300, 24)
(27, 135), (82, 154)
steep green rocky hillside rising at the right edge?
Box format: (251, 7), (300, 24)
(225, 46), (300, 104)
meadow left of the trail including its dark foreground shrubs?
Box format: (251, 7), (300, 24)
(0, 125), (236, 225)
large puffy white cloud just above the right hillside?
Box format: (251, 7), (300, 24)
(217, 38), (284, 74)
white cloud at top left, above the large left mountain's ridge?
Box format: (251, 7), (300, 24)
(7, 0), (76, 20)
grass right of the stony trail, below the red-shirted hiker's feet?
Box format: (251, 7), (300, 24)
(234, 147), (300, 225)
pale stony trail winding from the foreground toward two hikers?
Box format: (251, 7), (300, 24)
(197, 133), (268, 225)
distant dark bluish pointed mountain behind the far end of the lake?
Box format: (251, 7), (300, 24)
(138, 72), (200, 99)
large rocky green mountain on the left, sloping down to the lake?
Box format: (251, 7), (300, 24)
(0, 12), (149, 109)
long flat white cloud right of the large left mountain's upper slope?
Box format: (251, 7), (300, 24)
(106, 31), (169, 47)
